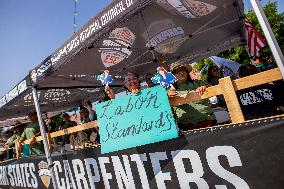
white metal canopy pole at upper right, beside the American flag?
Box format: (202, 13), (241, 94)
(250, 0), (284, 78)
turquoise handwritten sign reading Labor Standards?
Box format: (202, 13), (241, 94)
(96, 86), (178, 153)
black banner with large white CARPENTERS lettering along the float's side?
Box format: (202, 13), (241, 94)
(0, 117), (284, 189)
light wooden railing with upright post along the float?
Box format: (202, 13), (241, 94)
(0, 68), (282, 151)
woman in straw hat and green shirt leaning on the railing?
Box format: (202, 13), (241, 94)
(168, 63), (216, 131)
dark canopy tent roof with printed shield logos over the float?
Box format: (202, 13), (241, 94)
(0, 0), (243, 120)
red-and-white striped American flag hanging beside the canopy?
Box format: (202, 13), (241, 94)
(245, 19), (267, 57)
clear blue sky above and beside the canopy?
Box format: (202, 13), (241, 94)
(0, 0), (284, 98)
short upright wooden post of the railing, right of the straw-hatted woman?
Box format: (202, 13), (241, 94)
(219, 77), (245, 123)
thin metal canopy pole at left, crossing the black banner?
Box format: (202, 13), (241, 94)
(32, 87), (58, 189)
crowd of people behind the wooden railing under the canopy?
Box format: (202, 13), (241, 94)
(1, 63), (284, 159)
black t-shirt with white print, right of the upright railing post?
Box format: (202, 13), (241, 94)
(237, 84), (280, 120)
